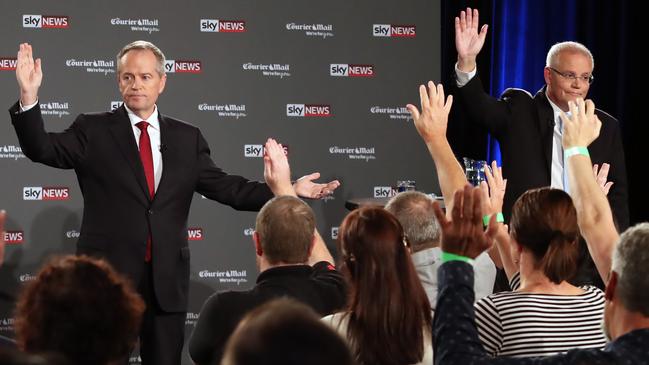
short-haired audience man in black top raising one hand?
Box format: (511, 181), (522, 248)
(189, 139), (346, 365)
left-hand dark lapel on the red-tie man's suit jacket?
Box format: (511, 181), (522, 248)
(109, 106), (154, 200)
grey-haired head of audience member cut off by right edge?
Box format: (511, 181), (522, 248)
(611, 222), (649, 317)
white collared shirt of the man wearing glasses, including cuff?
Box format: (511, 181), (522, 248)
(455, 62), (567, 191)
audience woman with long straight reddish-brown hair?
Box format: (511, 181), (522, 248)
(322, 207), (433, 365)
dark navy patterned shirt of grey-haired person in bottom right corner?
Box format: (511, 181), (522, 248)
(433, 261), (649, 365)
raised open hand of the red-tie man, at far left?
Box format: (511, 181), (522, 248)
(16, 43), (43, 106)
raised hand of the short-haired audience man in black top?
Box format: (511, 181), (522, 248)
(264, 138), (295, 196)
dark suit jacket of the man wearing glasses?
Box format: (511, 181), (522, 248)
(452, 75), (629, 230)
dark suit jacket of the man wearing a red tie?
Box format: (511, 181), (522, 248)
(9, 103), (272, 312)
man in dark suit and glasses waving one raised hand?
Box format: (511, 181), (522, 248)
(453, 8), (629, 230)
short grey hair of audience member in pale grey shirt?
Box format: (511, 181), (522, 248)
(385, 191), (440, 252)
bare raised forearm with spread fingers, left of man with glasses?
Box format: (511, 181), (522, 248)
(406, 81), (467, 212)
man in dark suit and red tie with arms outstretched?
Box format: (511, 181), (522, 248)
(10, 41), (339, 365)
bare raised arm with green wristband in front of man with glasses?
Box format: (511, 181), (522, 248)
(561, 99), (619, 281)
